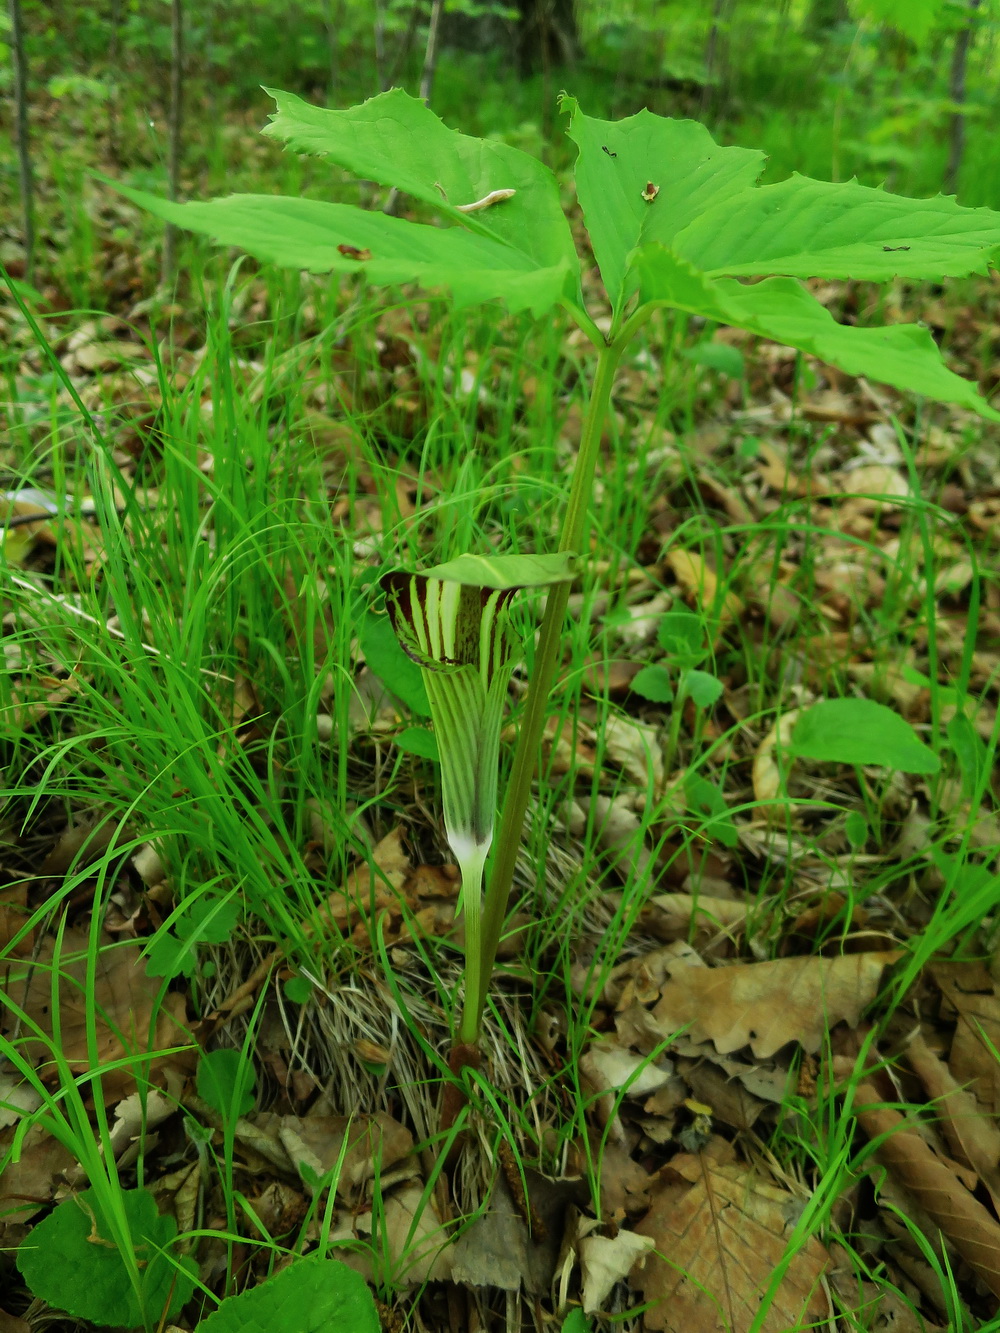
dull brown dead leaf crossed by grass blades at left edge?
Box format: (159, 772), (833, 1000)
(0, 928), (192, 1104)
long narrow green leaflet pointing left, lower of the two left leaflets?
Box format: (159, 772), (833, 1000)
(109, 183), (568, 316)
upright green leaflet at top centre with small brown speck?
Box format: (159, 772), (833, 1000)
(561, 97), (767, 315)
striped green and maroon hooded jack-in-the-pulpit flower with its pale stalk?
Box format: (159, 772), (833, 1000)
(381, 555), (575, 1045)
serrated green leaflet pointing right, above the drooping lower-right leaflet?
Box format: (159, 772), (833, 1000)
(677, 176), (1000, 283)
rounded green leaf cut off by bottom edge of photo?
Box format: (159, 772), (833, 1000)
(196, 1256), (380, 1333)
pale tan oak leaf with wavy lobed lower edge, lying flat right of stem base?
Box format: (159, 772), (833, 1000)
(651, 950), (900, 1060)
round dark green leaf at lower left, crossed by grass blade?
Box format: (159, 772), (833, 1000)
(17, 1189), (195, 1329)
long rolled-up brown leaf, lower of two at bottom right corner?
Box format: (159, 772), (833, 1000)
(837, 1060), (1000, 1296)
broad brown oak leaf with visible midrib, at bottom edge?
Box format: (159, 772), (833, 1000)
(632, 1150), (829, 1333)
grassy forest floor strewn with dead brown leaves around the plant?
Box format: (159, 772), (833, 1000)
(0, 77), (1000, 1333)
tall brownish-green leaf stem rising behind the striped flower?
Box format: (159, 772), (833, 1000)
(459, 338), (631, 1046)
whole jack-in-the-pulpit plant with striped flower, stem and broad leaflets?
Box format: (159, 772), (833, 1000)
(116, 89), (1000, 1044)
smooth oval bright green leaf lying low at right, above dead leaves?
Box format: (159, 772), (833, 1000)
(789, 698), (941, 773)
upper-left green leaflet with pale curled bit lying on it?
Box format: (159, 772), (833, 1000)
(264, 88), (580, 303)
